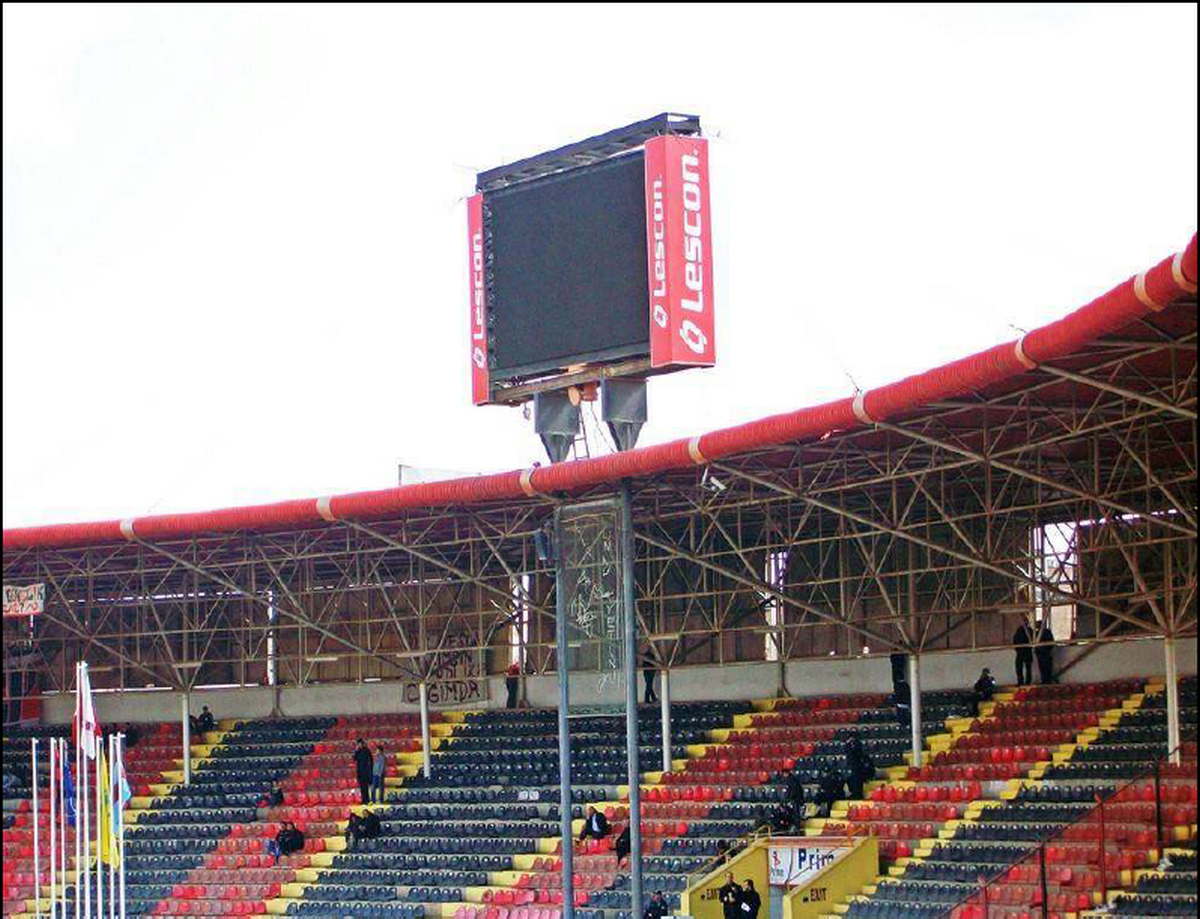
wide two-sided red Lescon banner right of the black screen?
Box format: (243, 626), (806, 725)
(646, 134), (716, 367)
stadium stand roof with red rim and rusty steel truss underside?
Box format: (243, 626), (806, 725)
(4, 233), (1196, 687)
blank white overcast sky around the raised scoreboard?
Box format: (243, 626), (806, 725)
(4, 4), (1196, 527)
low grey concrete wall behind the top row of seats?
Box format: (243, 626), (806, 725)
(37, 638), (1196, 723)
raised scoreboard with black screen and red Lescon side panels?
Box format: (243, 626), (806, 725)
(467, 114), (716, 404)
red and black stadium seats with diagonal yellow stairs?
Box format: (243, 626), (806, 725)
(5, 679), (1196, 919)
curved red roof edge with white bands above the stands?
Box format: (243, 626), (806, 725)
(4, 236), (1196, 551)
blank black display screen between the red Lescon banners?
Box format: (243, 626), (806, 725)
(484, 151), (650, 379)
